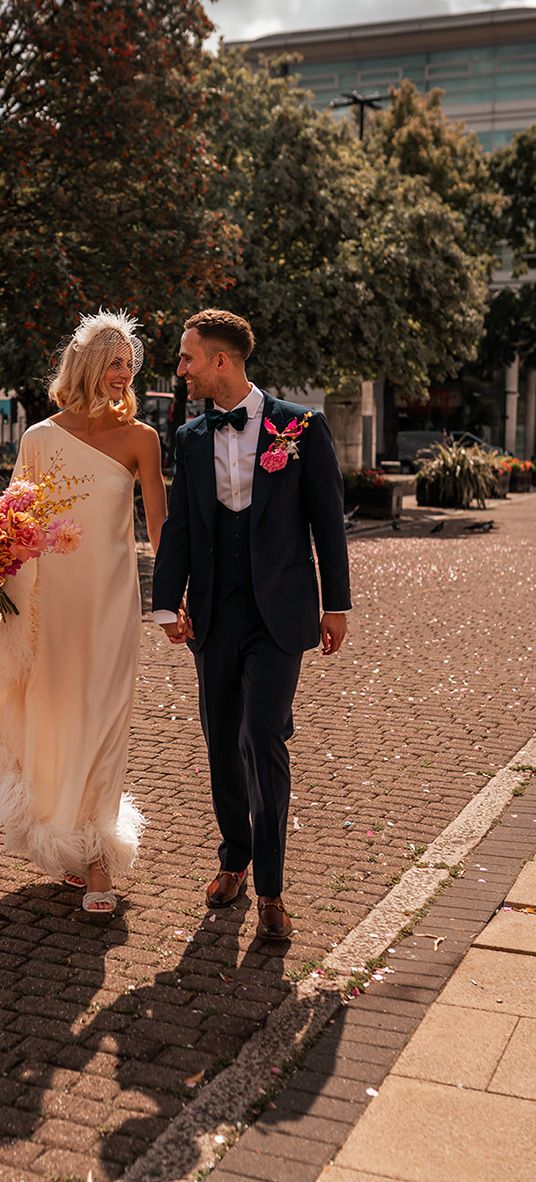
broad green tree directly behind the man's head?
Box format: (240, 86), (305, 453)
(212, 54), (486, 398)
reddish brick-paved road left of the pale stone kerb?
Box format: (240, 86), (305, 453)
(0, 495), (536, 1182)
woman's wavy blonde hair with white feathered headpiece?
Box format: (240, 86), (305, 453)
(49, 309), (143, 422)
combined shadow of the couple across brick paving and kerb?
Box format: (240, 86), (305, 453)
(0, 883), (300, 1182)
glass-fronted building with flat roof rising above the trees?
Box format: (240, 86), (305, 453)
(240, 5), (536, 151)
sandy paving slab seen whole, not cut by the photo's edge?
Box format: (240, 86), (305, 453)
(393, 1005), (517, 1089)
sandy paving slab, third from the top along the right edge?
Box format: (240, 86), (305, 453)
(438, 948), (536, 1018)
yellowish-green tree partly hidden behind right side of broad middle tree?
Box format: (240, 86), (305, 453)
(364, 79), (508, 454)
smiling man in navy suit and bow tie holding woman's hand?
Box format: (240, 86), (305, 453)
(153, 309), (350, 940)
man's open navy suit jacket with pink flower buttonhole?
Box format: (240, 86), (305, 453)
(153, 394), (351, 654)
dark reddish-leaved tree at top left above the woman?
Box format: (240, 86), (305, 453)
(0, 0), (238, 417)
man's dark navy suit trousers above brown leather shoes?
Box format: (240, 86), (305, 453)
(194, 587), (303, 898)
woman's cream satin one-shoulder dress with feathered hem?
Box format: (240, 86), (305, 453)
(0, 418), (143, 878)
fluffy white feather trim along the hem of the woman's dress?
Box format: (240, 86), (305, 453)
(0, 745), (146, 879)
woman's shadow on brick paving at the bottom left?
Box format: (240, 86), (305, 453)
(0, 883), (128, 1160)
